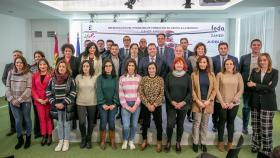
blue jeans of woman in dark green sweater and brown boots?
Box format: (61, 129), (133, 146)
(98, 105), (118, 131)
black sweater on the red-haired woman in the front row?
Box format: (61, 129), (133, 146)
(165, 72), (192, 109)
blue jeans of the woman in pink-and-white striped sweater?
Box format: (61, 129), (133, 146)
(122, 102), (140, 141)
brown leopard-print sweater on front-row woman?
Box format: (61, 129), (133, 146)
(139, 76), (164, 106)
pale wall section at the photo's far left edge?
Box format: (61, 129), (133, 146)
(0, 14), (32, 96)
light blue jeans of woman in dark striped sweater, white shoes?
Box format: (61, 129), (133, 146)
(57, 110), (72, 140)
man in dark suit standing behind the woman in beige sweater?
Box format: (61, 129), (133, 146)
(212, 42), (239, 132)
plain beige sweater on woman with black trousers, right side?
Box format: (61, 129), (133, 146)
(216, 72), (244, 105)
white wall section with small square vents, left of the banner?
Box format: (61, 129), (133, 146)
(31, 19), (69, 65)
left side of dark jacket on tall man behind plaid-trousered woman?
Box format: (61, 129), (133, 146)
(239, 53), (251, 92)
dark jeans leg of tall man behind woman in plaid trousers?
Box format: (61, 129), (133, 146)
(242, 92), (251, 129)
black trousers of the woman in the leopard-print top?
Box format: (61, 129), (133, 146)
(141, 106), (162, 141)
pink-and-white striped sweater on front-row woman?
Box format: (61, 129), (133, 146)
(119, 75), (141, 108)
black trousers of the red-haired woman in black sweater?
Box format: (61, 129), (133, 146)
(166, 107), (188, 143)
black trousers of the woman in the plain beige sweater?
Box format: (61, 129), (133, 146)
(217, 103), (239, 142)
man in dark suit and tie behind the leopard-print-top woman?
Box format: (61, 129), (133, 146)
(138, 43), (167, 78)
